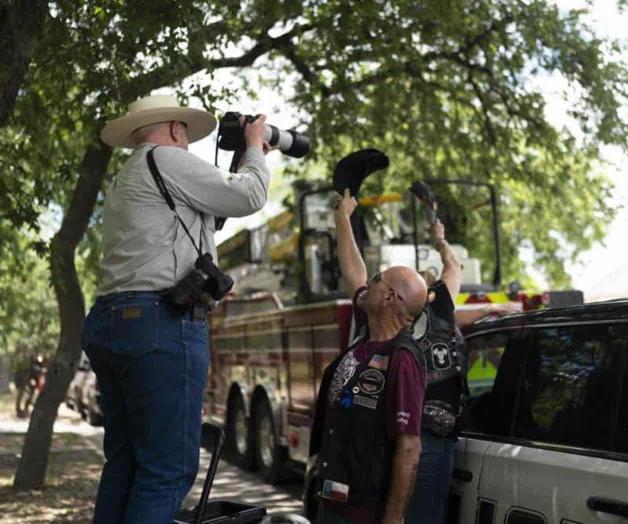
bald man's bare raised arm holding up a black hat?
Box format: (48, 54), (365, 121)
(335, 189), (367, 296)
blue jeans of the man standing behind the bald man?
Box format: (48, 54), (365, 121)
(406, 431), (455, 524)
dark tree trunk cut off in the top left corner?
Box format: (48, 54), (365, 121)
(0, 0), (48, 127)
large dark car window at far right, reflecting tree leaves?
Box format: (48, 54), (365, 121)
(514, 324), (621, 449)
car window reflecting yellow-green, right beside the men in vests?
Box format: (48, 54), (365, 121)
(463, 329), (525, 435)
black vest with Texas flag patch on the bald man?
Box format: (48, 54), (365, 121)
(318, 330), (421, 505)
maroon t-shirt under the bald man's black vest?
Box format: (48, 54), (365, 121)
(321, 287), (426, 524)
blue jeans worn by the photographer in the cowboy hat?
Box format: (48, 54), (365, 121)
(83, 292), (209, 524)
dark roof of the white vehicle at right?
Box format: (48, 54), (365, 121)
(465, 298), (628, 335)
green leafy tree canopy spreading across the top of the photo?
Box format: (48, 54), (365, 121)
(0, 0), (627, 350)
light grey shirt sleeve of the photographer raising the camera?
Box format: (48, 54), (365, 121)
(154, 146), (270, 217)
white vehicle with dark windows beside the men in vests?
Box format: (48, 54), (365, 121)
(446, 300), (628, 524)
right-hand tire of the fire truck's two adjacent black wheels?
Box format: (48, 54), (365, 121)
(254, 399), (288, 484)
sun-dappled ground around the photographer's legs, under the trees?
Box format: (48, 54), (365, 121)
(0, 394), (302, 524)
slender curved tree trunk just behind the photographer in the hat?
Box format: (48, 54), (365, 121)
(13, 140), (111, 490)
